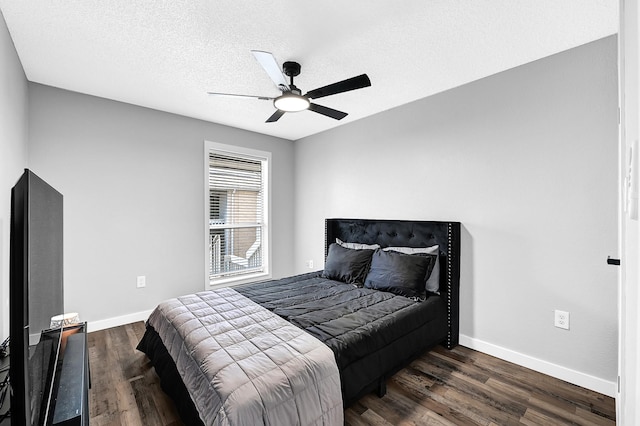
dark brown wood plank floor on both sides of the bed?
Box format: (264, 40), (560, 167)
(89, 322), (615, 426)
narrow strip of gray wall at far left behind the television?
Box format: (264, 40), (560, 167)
(0, 10), (28, 340)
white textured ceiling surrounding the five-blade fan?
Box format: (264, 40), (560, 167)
(0, 0), (618, 140)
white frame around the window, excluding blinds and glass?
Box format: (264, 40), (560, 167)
(203, 141), (271, 290)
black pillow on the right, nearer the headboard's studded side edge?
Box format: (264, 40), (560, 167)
(364, 250), (436, 297)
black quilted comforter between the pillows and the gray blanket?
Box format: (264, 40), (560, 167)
(234, 272), (447, 403)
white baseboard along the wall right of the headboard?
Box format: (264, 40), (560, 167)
(459, 334), (616, 398)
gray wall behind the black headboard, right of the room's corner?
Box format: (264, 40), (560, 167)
(295, 37), (618, 382)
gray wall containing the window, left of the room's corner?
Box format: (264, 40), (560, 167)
(29, 83), (293, 321)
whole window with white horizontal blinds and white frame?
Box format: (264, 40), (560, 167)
(205, 142), (270, 285)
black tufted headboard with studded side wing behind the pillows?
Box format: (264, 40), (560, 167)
(325, 219), (460, 349)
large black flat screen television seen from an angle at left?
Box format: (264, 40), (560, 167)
(9, 169), (64, 426)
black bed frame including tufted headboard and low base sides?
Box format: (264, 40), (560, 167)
(138, 219), (460, 425)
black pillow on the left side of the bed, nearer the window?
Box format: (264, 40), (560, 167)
(322, 243), (374, 285)
